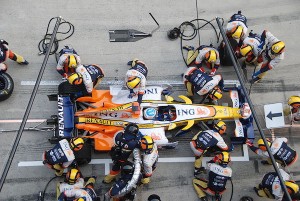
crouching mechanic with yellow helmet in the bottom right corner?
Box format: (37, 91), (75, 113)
(254, 169), (300, 201)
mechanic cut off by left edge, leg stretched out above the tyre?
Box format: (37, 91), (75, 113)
(0, 39), (29, 73)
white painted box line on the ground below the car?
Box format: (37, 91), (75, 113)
(18, 144), (249, 174)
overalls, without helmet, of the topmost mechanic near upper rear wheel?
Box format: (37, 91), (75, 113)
(56, 46), (81, 77)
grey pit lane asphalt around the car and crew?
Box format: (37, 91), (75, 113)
(0, 0), (300, 201)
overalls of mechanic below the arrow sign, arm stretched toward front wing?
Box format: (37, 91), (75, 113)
(250, 137), (298, 167)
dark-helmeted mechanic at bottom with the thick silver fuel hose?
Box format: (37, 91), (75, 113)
(104, 148), (142, 201)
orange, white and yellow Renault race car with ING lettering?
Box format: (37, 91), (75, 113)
(49, 81), (250, 151)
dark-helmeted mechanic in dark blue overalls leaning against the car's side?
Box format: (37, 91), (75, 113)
(102, 123), (142, 184)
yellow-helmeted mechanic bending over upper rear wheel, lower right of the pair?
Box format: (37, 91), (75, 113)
(67, 64), (104, 95)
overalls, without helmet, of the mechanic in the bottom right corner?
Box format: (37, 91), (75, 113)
(254, 169), (290, 201)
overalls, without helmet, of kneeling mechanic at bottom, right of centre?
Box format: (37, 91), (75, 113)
(193, 160), (232, 199)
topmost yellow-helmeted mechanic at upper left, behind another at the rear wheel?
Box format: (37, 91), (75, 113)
(56, 46), (81, 78)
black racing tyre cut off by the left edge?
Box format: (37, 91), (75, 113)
(0, 73), (14, 101)
